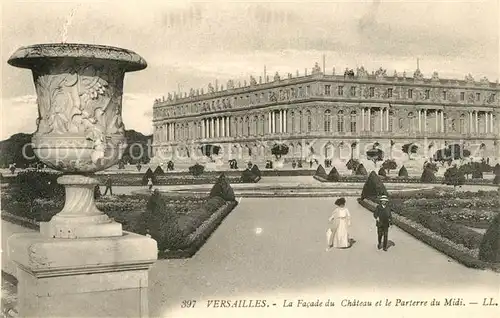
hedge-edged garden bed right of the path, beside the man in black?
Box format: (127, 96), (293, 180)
(358, 175), (500, 271)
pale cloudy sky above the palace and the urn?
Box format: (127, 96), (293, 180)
(0, 0), (500, 139)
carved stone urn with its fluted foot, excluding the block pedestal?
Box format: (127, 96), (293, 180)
(8, 43), (147, 238)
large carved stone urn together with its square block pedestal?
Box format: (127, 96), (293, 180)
(8, 44), (157, 317)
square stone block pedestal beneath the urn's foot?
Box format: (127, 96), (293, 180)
(8, 232), (158, 317)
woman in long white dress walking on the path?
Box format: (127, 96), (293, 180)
(328, 198), (351, 248)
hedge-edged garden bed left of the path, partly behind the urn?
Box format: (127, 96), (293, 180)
(1, 171), (237, 258)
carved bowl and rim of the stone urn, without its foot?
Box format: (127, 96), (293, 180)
(9, 44), (146, 173)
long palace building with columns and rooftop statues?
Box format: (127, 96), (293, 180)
(153, 63), (500, 164)
